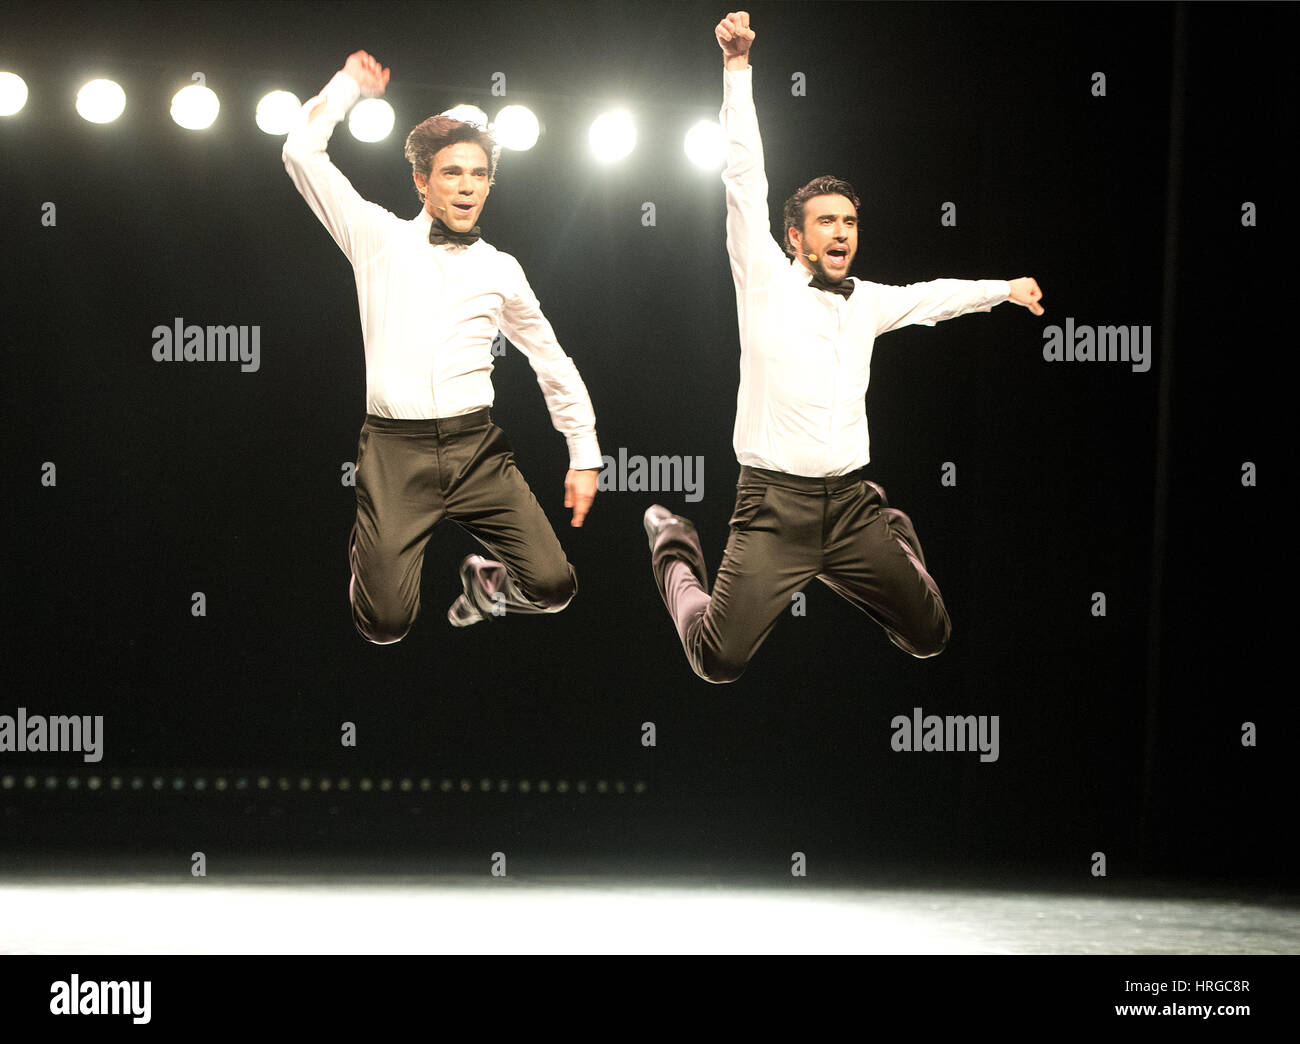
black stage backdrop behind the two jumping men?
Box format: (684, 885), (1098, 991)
(0, 3), (1296, 880)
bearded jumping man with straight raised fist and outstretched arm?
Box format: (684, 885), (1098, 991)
(645, 12), (1044, 683)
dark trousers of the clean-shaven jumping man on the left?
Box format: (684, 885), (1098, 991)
(348, 410), (577, 645)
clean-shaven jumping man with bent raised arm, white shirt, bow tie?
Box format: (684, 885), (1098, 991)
(283, 51), (602, 645)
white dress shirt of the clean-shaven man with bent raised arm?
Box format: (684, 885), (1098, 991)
(282, 73), (603, 468)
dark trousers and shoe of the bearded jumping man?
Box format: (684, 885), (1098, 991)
(651, 467), (952, 681)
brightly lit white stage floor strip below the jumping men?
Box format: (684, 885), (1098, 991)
(0, 876), (1300, 954)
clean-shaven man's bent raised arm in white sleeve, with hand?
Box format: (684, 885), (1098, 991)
(281, 51), (393, 265)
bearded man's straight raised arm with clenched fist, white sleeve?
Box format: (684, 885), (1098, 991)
(714, 10), (785, 291)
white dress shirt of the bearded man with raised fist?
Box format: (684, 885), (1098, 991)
(722, 69), (1011, 477)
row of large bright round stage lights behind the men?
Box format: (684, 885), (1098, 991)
(0, 73), (727, 170)
